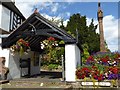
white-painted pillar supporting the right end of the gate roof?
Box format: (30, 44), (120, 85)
(65, 44), (81, 82)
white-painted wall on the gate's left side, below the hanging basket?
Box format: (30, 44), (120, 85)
(0, 38), (40, 79)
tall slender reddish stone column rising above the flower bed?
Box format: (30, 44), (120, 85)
(97, 2), (106, 52)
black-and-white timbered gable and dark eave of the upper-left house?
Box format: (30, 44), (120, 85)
(0, 1), (26, 32)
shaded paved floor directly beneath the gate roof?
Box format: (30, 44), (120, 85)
(11, 71), (62, 82)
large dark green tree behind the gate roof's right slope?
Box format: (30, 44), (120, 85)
(61, 13), (100, 54)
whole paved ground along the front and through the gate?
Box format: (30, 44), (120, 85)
(2, 71), (120, 90)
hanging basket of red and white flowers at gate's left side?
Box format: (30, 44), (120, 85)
(10, 39), (30, 56)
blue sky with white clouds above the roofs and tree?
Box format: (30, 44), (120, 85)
(15, 0), (119, 52)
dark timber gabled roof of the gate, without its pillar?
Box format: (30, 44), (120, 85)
(2, 13), (77, 52)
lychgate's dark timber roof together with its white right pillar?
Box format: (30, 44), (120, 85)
(2, 13), (80, 81)
